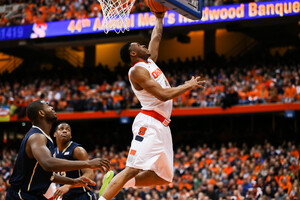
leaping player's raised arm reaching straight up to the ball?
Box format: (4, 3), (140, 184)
(148, 14), (163, 62)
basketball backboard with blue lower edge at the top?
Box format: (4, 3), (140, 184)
(155, 0), (202, 20)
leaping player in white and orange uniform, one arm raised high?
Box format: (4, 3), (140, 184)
(99, 13), (205, 200)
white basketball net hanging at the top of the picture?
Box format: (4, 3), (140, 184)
(98, 0), (135, 34)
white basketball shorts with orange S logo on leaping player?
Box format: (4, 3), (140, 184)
(126, 113), (174, 182)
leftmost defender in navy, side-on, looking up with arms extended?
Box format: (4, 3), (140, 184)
(6, 100), (109, 200)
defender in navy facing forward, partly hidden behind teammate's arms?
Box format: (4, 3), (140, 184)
(53, 123), (95, 200)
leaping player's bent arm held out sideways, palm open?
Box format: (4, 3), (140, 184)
(130, 67), (205, 101)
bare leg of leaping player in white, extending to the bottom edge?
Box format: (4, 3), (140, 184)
(99, 167), (140, 200)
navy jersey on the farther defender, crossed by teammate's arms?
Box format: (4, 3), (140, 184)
(54, 141), (88, 199)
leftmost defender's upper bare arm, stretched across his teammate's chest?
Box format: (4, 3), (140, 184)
(26, 134), (110, 172)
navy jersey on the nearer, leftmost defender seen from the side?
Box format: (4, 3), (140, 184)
(9, 126), (54, 196)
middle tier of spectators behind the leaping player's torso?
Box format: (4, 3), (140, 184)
(0, 48), (300, 118)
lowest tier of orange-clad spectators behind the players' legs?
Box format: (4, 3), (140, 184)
(0, 141), (300, 200)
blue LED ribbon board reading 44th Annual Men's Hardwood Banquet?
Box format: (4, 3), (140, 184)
(0, 0), (300, 41)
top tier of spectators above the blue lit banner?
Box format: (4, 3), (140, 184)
(0, 0), (278, 27)
